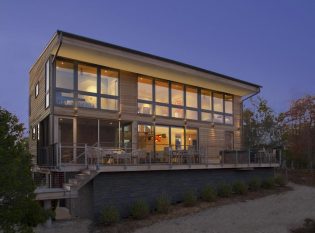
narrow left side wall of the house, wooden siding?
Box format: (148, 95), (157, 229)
(29, 38), (58, 162)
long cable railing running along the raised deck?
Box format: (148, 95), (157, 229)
(37, 144), (281, 168)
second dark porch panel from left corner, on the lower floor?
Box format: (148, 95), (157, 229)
(77, 118), (98, 146)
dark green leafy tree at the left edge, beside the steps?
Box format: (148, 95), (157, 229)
(0, 107), (49, 233)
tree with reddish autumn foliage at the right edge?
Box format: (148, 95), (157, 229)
(283, 95), (315, 168)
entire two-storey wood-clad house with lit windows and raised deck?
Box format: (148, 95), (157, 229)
(29, 31), (279, 217)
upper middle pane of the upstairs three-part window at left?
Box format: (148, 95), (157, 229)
(78, 65), (97, 93)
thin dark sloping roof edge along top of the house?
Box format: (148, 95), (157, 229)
(57, 30), (262, 88)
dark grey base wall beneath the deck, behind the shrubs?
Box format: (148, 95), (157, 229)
(72, 168), (273, 218)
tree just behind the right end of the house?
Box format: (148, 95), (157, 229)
(243, 96), (282, 148)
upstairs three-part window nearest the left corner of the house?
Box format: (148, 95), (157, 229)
(55, 59), (119, 111)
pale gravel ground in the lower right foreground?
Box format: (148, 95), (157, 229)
(136, 184), (315, 233)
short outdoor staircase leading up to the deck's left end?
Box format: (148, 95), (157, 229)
(63, 169), (99, 195)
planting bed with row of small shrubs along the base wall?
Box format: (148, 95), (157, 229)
(92, 179), (291, 233)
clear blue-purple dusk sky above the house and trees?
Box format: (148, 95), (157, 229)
(0, 0), (315, 129)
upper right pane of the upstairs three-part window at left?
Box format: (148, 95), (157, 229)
(101, 69), (118, 96)
